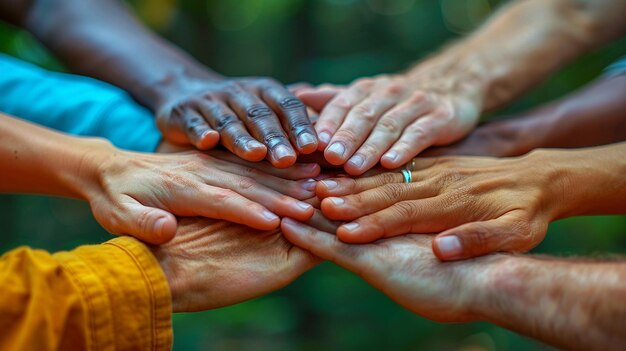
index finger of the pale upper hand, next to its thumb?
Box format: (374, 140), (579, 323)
(315, 79), (374, 153)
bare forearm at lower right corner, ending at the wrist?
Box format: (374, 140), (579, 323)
(476, 256), (626, 350)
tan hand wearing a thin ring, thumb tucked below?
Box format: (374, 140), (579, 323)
(317, 151), (571, 260)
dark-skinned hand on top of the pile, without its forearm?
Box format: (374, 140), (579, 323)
(157, 78), (318, 167)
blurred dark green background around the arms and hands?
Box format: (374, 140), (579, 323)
(0, 0), (626, 351)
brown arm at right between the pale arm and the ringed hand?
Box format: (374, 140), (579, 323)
(422, 75), (626, 157)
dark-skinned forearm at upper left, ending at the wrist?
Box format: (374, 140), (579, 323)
(24, 0), (218, 110)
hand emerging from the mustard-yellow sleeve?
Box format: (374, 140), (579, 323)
(152, 218), (319, 312)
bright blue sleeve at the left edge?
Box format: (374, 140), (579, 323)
(0, 54), (161, 152)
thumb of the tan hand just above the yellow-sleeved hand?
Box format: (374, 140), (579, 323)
(105, 196), (177, 245)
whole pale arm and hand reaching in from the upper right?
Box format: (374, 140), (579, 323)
(297, 0), (626, 175)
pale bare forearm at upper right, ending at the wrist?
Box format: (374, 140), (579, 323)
(409, 0), (626, 110)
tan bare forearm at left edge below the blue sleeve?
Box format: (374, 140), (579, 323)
(0, 114), (114, 199)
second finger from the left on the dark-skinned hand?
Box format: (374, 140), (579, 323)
(199, 102), (267, 162)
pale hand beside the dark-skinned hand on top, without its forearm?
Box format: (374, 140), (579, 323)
(297, 73), (481, 175)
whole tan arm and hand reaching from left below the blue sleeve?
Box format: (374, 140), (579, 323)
(0, 115), (319, 243)
